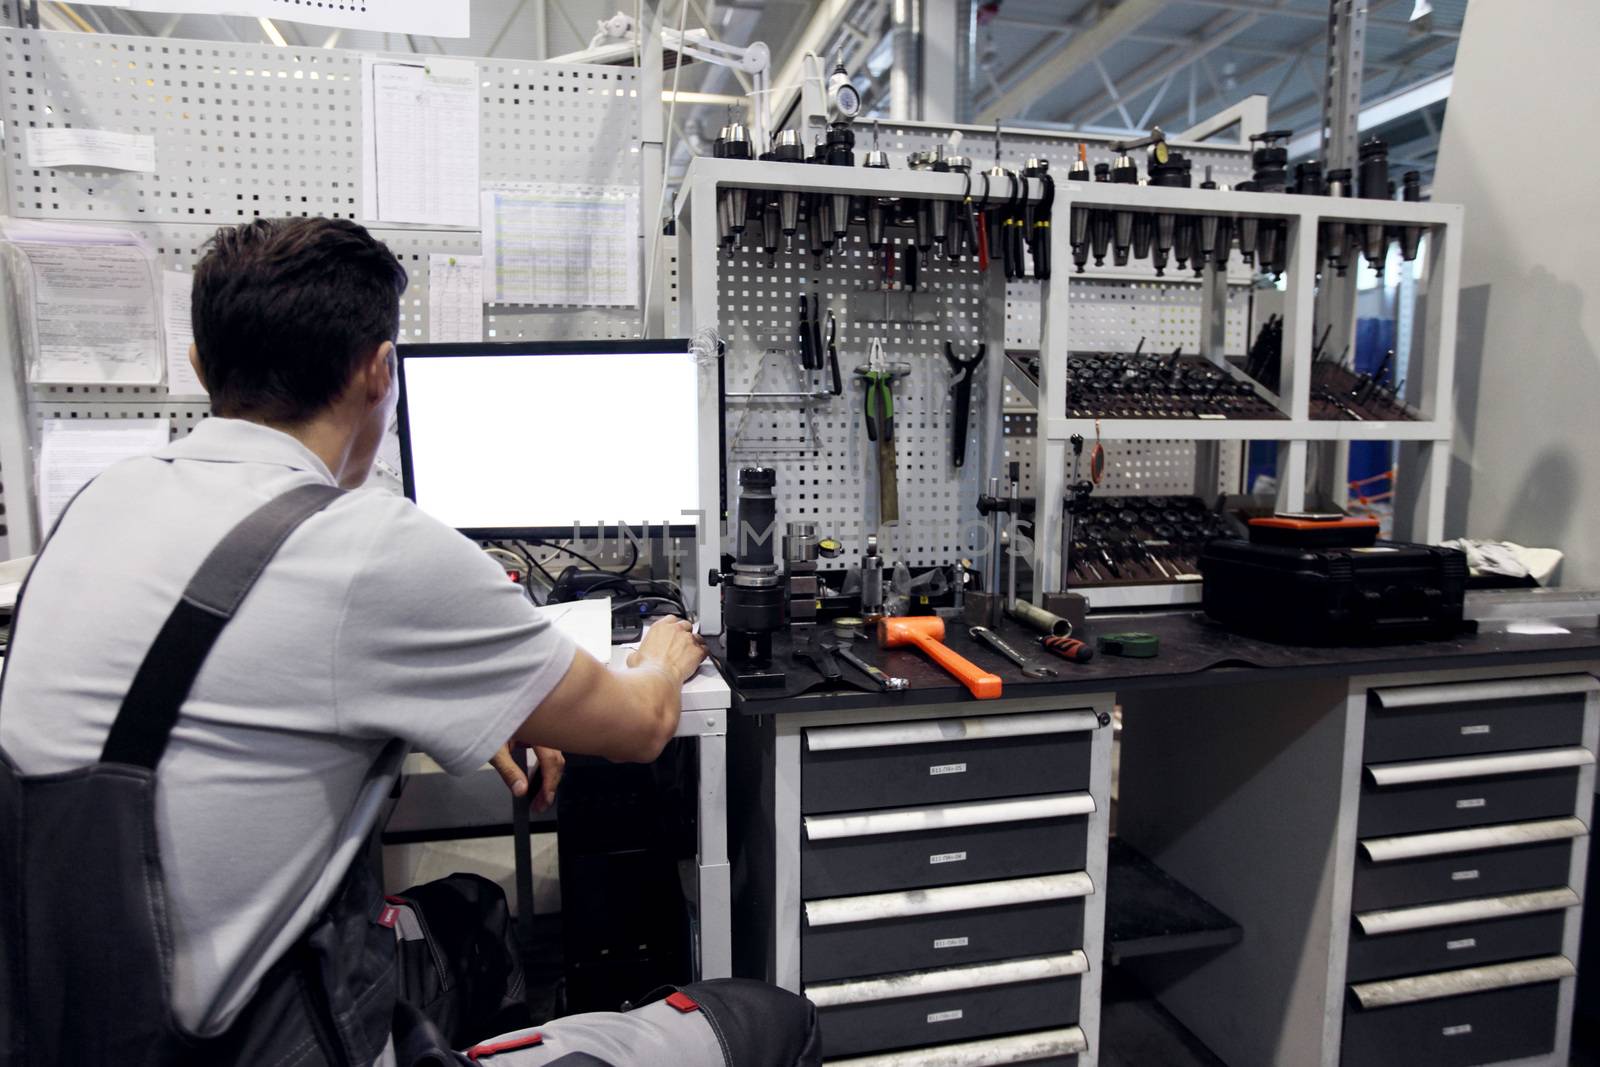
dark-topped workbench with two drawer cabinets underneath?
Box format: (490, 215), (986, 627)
(728, 614), (1600, 1067)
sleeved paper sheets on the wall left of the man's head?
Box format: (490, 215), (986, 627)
(5, 219), (163, 386)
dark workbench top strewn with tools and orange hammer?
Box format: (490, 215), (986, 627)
(714, 613), (1600, 715)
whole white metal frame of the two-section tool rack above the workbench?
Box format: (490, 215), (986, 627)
(677, 158), (1464, 633)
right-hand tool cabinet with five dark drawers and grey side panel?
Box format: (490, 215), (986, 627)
(1118, 656), (1600, 1067)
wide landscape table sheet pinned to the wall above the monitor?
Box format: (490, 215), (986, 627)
(483, 182), (640, 307)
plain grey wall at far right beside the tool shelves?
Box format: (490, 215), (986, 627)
(1434, 0), (1600, 589)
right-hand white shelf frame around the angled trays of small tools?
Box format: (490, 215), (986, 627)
(1034, 181), (1464, 606)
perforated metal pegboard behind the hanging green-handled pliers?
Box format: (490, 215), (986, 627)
(718, 234), (997, 566)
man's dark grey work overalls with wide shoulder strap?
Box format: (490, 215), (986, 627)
(0, 485), (821, 1067)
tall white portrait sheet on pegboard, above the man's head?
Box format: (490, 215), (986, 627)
(362, 56), (478, 229)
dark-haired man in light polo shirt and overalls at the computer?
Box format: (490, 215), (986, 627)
(0, 219), (818, 1067)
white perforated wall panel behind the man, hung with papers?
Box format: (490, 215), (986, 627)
(0, 29), (649, 558)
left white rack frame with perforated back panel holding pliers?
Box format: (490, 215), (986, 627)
(677, 158), (1043, 633)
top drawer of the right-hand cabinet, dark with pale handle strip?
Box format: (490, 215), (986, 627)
(1365, 675), (1600, 763)
